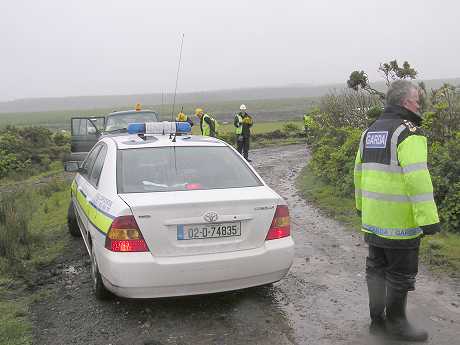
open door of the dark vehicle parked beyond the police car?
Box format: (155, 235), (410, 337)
(70, 116), (105, 153)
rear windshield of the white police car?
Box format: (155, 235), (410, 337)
(117, 146), (262, 194)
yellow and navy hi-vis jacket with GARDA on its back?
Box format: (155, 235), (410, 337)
(354, 117), (439, 240)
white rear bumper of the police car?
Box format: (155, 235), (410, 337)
(98, 237), (294, 298)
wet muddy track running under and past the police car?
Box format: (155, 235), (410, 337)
(33, 145), (460, 345)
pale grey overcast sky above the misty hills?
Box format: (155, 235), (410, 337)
(0, 0), (460, 101)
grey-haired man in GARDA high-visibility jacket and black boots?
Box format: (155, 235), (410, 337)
(354, 80), (440, 341)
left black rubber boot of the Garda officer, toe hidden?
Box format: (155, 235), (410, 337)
(367, 275), (386, 335)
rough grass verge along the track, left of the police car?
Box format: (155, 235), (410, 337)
(0, 181), (70, 345)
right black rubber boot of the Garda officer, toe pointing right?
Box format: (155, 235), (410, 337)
(385, 287), (428, 341)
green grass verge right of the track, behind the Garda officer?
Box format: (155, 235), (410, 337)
(296, 166), (460, 274)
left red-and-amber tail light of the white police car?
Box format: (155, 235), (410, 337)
(105, 216), (149, 252)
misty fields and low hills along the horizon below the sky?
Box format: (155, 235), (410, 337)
(0, 78), (460, 129)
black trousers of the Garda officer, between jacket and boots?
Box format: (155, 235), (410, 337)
(366, 245), (419, 291)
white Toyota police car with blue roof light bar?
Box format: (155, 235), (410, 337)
(66, 122), (294, 298)
